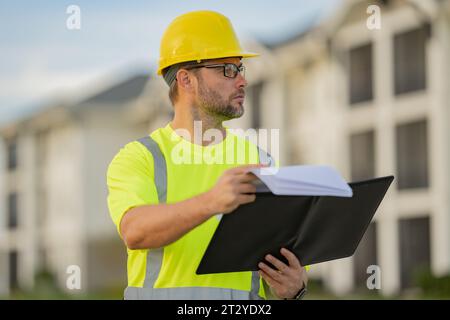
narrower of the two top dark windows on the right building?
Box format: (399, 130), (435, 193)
(349, 44), (373, 104)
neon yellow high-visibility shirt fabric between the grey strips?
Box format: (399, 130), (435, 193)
(107, 123), (265, 297)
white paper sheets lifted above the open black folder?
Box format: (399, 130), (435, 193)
(250, 165), (353, 197)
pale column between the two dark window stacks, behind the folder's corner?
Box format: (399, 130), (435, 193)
(373, 15), (400, 295)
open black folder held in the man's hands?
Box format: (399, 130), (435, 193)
(196, 176), (394, 274)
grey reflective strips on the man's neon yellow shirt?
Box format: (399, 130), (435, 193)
(124, 136), (274, 300)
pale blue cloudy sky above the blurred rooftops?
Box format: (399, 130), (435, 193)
(0, 0), (342, 124)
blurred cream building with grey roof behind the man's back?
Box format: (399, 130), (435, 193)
(0, 75), (170, 294)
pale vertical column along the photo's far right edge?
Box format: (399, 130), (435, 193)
(427, 10), (450, 275)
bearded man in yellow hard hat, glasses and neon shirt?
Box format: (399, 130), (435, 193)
(107, 11), (307, 299)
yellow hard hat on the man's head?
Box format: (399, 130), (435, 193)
(158, 11), (258, 75)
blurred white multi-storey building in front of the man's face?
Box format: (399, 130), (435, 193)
(244, 0), (450, 294)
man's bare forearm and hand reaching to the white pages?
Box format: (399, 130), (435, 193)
(120, 165), (268, 249)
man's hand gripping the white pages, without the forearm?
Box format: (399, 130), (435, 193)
(206, 164), (265, 214)
